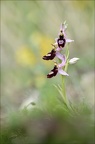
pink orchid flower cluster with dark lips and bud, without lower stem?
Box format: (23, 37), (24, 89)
(43, 21), (79, 78)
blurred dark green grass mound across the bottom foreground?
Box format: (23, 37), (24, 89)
(0, 103), (94, 144)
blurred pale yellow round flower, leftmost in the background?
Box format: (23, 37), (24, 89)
(16, 46), (36, 66)
